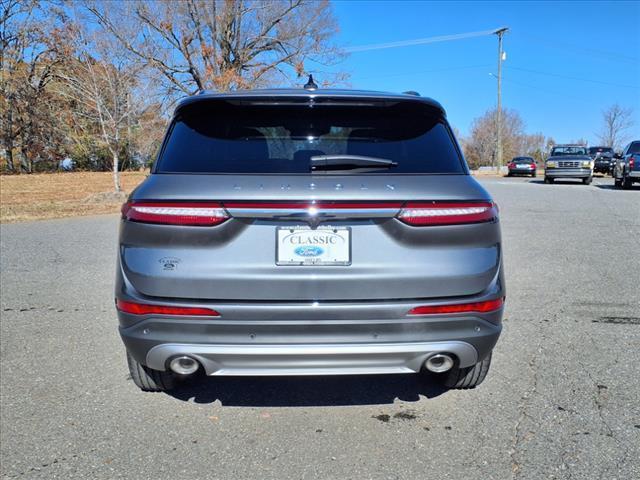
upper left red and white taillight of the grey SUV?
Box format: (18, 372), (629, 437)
(122, 201), (229, 227)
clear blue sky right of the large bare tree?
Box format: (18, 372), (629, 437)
(333, 0), (640, 144)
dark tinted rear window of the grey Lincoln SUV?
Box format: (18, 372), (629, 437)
(155, 101), (466, 175)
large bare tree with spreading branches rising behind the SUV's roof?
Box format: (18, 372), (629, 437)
(85, 0), (342, 97)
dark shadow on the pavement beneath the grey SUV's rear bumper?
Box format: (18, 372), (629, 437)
(168, 374), (447, 407)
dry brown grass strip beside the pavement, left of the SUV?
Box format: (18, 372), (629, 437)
(0, 172), (147, 223)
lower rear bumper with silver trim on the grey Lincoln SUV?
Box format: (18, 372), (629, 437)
(119, 302), (502, 375)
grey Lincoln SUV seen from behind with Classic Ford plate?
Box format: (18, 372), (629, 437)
(116, 89), (505, 391)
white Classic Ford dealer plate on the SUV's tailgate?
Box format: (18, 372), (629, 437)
(276, 226), (351, 265)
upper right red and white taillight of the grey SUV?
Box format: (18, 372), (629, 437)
(398, 202), (498, 226)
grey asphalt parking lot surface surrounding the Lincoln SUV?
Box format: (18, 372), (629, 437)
(0, 177), (640, 479)
